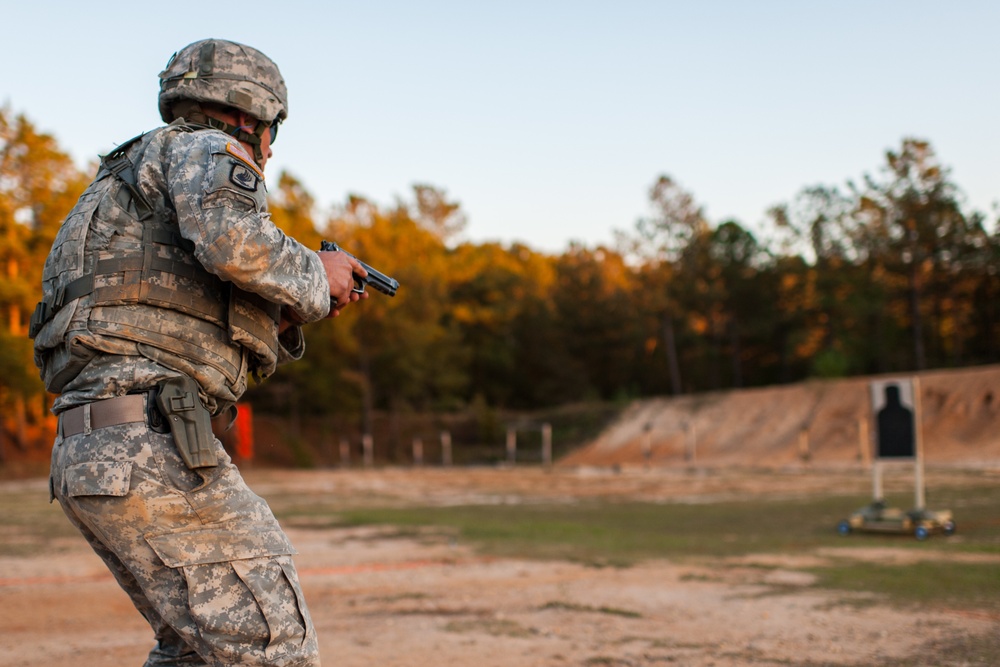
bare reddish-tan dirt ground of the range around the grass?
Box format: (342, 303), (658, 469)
(0, 466), (1000, 667)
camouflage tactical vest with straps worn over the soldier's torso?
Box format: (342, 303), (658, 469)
(30, 123), (280, 400)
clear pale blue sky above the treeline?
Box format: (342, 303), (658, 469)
(0, 0), (1000, 252)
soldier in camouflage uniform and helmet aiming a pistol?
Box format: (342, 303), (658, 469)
(32, 39), (367, 667)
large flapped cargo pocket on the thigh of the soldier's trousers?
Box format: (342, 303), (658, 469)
(146, 527), (310, 663)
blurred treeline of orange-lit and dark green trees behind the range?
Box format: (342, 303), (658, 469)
(0, 103), (1000, 448)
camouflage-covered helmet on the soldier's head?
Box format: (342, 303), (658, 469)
(160, 39), (288, 123)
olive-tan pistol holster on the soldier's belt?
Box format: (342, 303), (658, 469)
(156, 376), (219, 470)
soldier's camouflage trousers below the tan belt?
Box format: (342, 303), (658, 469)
(50, 400), (320, 667)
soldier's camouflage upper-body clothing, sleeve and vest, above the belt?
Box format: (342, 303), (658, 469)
(35, 123), (330, 414)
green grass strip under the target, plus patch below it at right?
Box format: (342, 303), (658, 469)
(270, 485), (1000, 611)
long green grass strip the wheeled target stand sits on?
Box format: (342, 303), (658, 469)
(292, 486), (1000, 566)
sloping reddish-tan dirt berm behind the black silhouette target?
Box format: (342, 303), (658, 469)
(560, 365), (1000, 467)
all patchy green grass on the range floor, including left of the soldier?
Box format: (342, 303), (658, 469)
(0, 472), (1000, 667)
